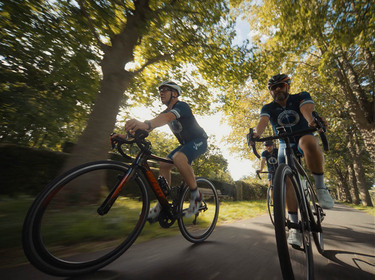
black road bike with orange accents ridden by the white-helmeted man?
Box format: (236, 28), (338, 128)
(22, 131), (219, 276)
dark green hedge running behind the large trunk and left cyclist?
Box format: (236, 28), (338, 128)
(0, 144), (266, 200)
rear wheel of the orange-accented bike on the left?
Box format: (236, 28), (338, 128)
(178, 178), (219, 243)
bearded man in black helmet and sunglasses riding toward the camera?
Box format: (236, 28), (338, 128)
(254, 74), (334, 246)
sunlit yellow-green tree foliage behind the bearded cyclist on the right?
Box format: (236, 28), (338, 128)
(223, 0), (375, 206)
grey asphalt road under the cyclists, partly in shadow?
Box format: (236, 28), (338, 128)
(0, 202), (375, 280)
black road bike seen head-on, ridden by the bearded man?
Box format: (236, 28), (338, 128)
(248, 112), (328, 280)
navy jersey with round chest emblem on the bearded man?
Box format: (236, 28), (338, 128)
(260, 91), (314, 143)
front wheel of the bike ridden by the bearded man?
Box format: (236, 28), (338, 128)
(274, 163), (314, 280)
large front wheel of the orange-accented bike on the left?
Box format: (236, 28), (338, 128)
(22, 161), (149, 276)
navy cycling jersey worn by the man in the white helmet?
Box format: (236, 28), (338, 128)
(162, 101), (208, 145)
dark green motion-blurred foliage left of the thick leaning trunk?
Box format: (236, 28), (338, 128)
(0, 0), (99, 149)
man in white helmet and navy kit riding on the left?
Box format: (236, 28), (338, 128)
(112, 81), (208, 222)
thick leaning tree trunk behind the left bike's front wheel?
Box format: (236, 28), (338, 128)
(59, 0), (149, 201)
